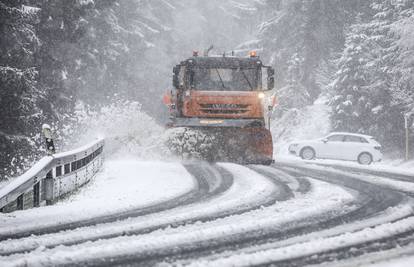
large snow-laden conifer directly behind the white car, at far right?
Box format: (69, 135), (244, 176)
(332, 1), (412, 151)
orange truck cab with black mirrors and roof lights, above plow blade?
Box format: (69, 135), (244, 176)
(164, 53), (274, 127)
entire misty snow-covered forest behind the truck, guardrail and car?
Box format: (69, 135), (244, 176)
(0, 0), (414, 180)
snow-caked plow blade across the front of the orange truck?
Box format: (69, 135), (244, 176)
(167, 120), (273, 165)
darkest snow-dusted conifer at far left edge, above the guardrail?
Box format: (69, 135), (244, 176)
(0, 1), (47, 179)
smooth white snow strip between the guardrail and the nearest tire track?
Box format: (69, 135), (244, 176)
(0, 160), (197, 234)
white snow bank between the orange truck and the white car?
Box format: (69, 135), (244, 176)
(271, 96), (331, 155)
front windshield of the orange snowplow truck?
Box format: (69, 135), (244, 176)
(192, 67), (258, 91)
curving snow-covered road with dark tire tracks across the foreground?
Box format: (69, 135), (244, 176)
(0, 160), (414, 266)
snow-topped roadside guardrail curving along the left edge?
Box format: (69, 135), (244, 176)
(0, 139), (104, 212)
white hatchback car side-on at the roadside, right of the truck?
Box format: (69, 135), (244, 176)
(289, 132), (382, 165)
